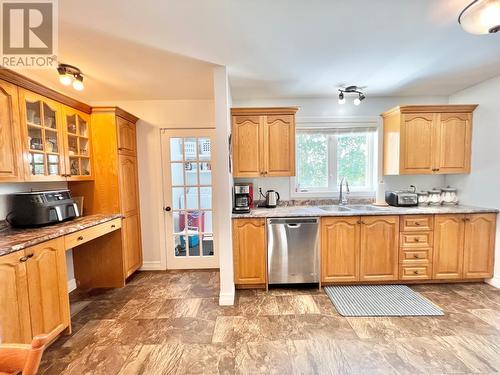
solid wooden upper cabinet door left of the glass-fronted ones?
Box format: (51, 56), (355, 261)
(0, 80), (24, 182)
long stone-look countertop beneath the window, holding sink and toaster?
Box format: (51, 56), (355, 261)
(232, 205), (499, 219)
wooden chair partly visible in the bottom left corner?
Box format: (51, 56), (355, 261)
(0, 335), (49, 375)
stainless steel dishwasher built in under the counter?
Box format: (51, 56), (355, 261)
(267, 217), (319, 284)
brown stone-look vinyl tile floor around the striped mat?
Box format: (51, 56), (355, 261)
(39, 271), (500, 375)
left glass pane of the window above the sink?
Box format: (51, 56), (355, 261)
(297, 133), (328, 188)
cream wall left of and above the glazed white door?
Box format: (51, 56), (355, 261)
(91, 100), (215, 270)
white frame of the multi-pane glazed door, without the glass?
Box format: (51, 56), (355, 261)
(160, 128), (219, 270)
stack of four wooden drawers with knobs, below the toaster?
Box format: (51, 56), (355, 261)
(399, 215), (434, 280)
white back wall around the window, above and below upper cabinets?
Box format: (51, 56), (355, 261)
(232, 96), (448, 200)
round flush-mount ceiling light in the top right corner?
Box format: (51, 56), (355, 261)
(458, 0), (500, 35)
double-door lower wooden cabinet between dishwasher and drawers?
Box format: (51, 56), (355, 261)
(321, 216), (399, 283)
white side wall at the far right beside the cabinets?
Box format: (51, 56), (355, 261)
(446, 76), (500, 287)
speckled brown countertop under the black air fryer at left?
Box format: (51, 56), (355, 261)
(0, 214), (122, 256)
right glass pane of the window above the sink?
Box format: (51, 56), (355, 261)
(337, 133), (371, 187)
